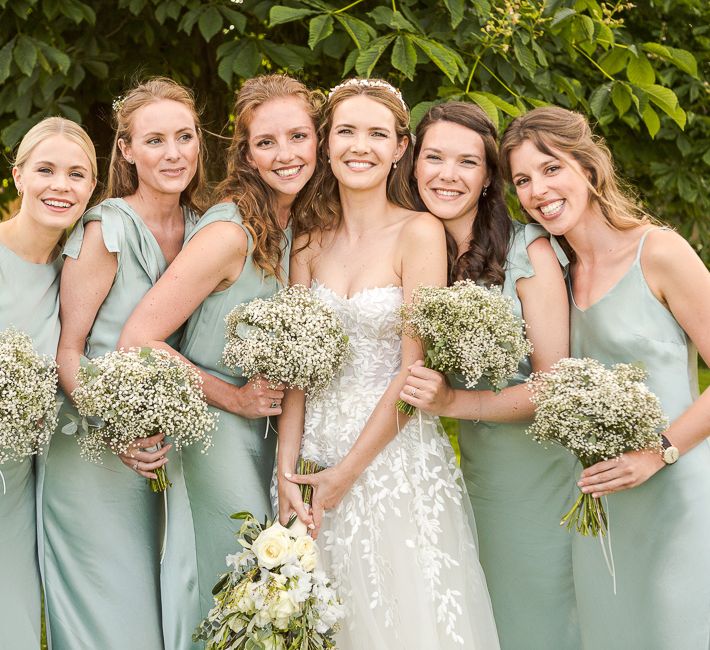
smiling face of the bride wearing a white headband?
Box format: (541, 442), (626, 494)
(328, 95), (408, 190)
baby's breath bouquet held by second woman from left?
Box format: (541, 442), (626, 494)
(72, 348), (217, 492)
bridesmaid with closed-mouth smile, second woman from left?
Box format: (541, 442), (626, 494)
(39, 78), (203, 650)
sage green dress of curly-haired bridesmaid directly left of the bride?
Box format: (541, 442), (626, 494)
(163, 203), (291, 650)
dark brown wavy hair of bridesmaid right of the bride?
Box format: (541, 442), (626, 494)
(412, 102), (512, 285)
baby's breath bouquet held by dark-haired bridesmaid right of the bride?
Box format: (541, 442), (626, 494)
(397, 280), (532, 415)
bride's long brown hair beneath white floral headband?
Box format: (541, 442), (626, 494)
(300, 79), (417, 235)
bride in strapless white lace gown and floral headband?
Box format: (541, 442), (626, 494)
(277, 79), (499, 650)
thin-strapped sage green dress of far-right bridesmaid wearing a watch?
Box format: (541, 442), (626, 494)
(570, 229), (710, 650)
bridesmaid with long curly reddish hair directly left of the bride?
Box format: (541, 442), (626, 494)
(120, 75), (320, 649)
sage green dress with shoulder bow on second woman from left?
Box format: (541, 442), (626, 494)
(37, 198), (195, 650)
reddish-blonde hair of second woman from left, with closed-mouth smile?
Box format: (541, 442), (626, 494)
(102, 77), (205, 214)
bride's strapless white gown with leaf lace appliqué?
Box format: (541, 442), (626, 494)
(301, 282), (499, 650)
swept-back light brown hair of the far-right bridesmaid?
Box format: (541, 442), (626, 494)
(500, 106), (655, 230)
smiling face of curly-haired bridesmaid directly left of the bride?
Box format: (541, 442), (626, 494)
(247, 97), (318, 204)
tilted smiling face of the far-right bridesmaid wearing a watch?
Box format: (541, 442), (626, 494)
(510, 140), (593, 236)
